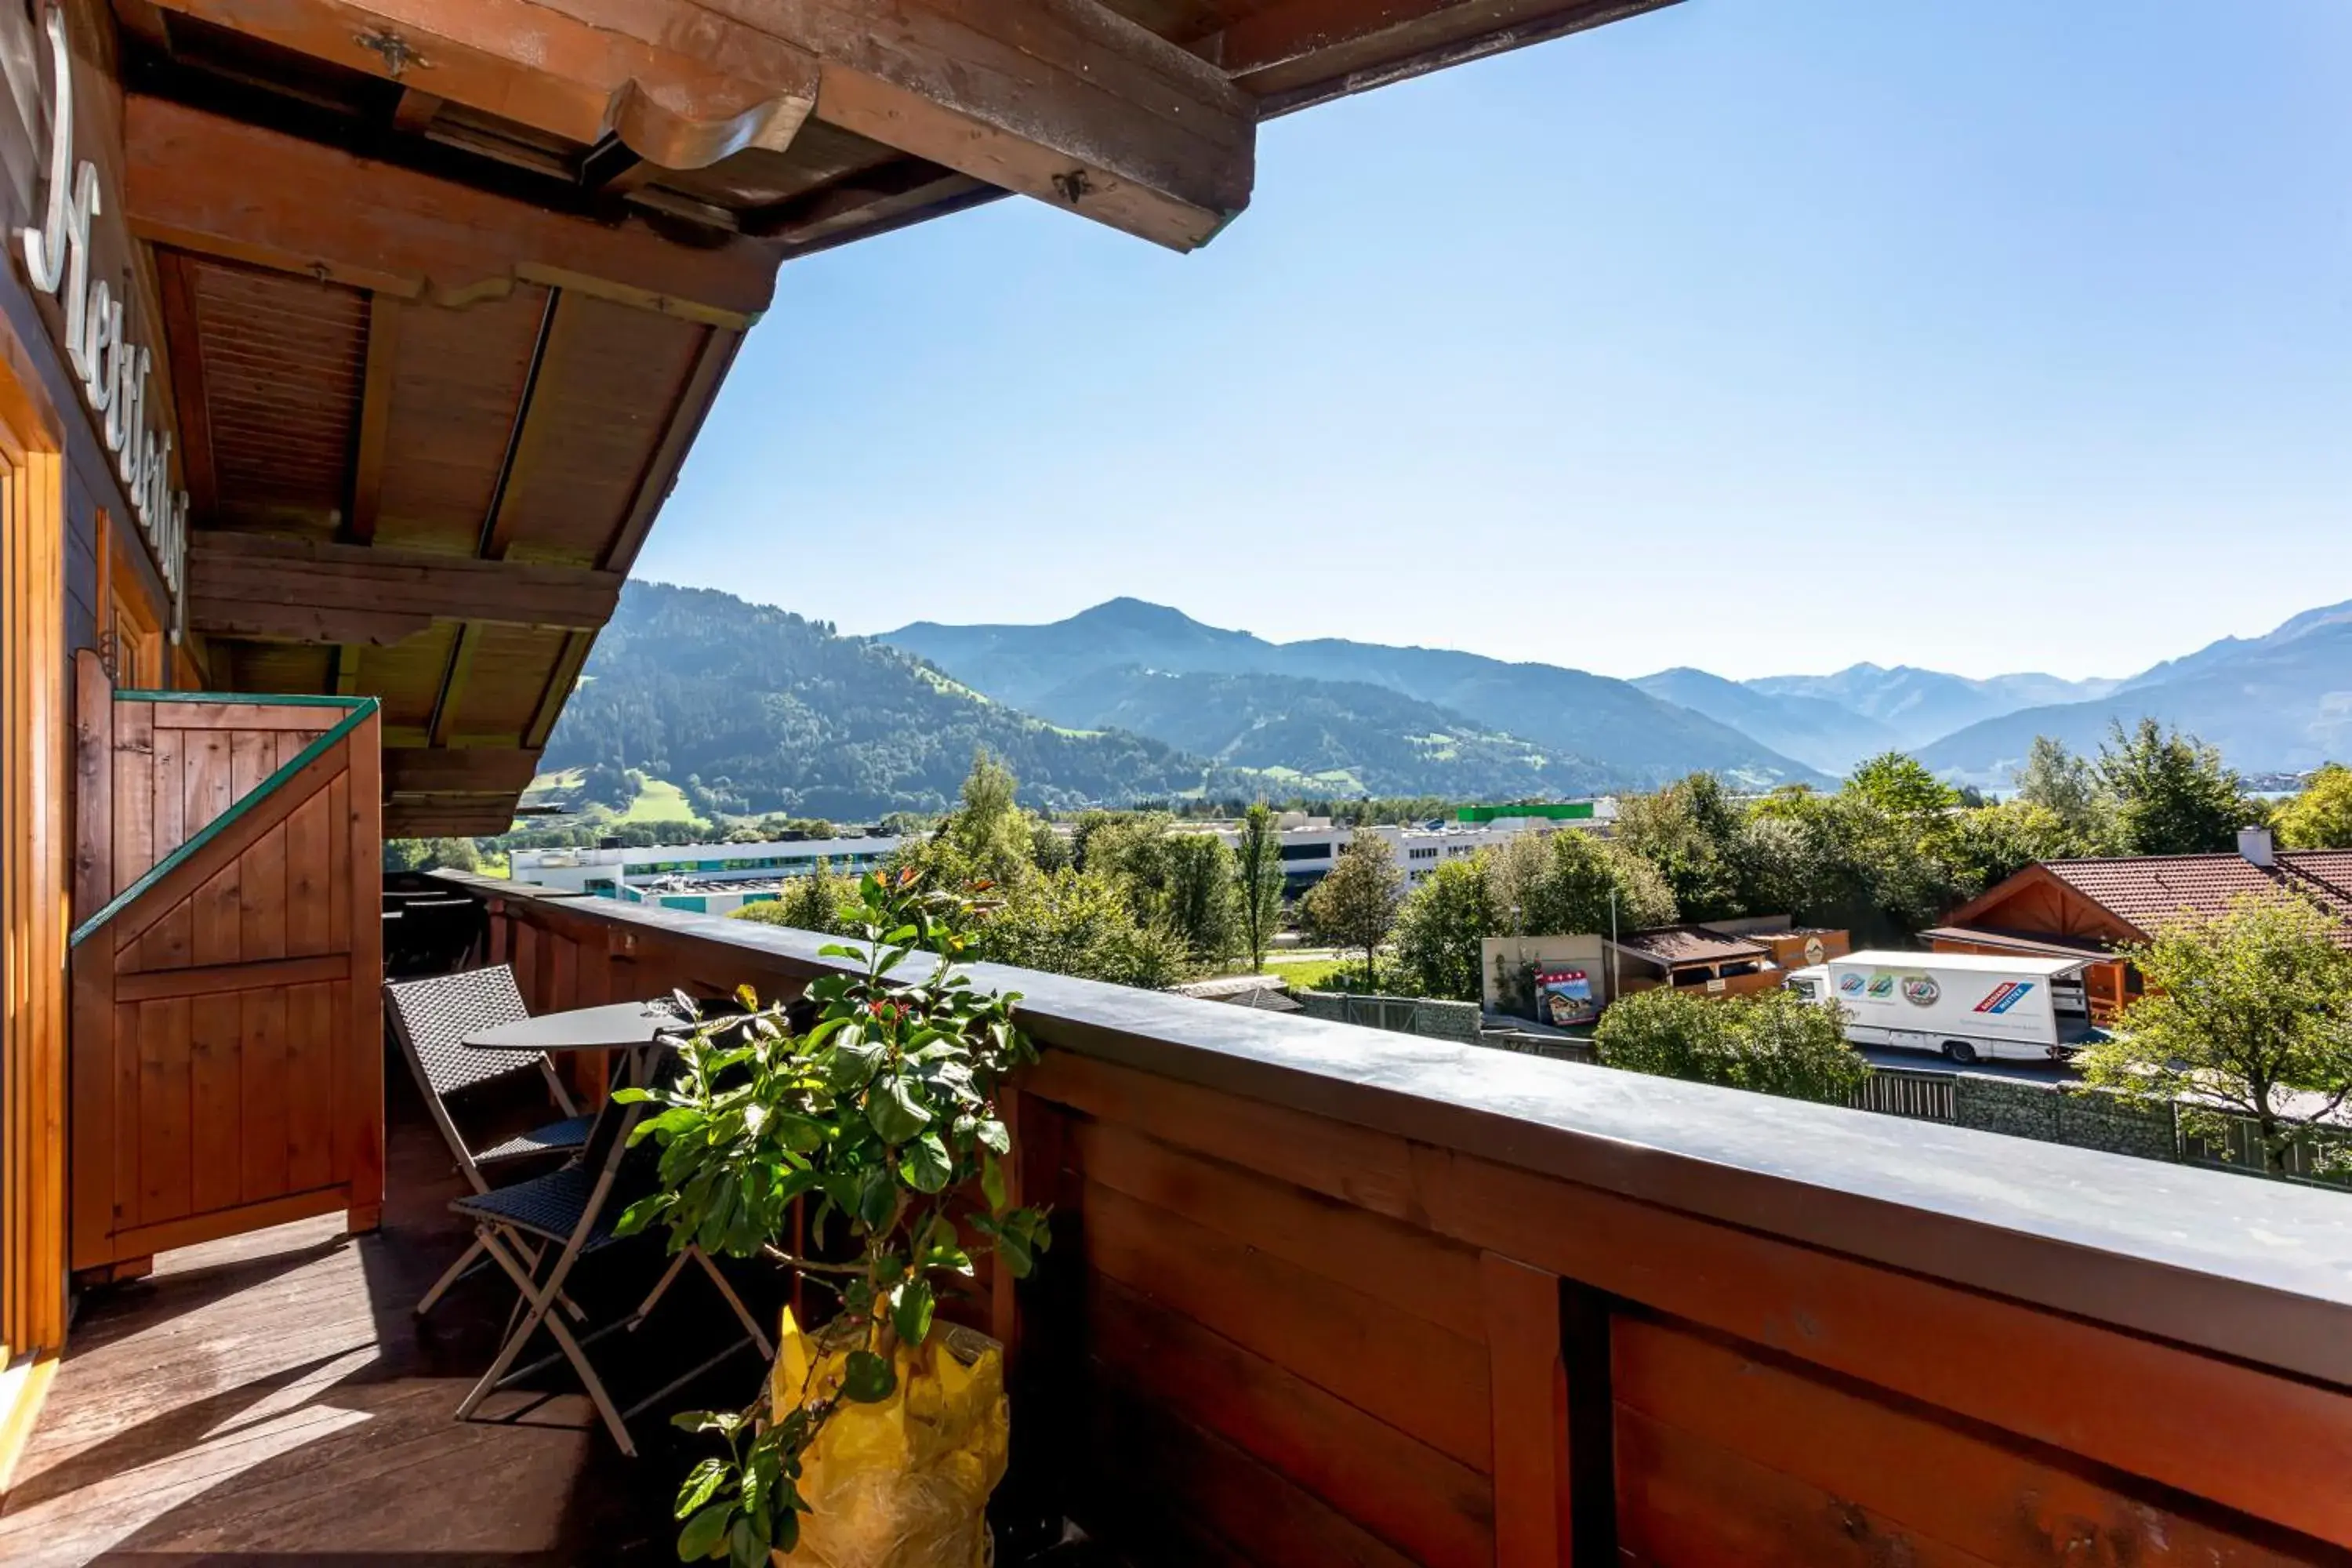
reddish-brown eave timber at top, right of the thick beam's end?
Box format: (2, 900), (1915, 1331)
(1192, 0), (1677, 115)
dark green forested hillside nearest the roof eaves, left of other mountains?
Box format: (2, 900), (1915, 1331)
(543, 583), (1204, 820)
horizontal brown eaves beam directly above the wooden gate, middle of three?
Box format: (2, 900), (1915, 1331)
(188, 529), (621, 644)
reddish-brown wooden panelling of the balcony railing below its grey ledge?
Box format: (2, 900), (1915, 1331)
(477, 898), (2352, 1568)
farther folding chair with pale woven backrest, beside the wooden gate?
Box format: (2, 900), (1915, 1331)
(383, 964), (595, 1316)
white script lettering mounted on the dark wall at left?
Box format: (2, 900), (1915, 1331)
(21, 7), (188, 642)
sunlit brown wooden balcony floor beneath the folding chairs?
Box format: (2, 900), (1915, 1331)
(0, 1083), (755, 1568)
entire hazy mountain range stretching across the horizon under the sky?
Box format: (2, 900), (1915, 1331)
(543, 583), (2352, 818)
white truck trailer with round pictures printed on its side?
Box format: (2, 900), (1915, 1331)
(1785, 952), (2096, 1065)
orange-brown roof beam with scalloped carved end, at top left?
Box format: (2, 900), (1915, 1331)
(147, 0), (816, 169)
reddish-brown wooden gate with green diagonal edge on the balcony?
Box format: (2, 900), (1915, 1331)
(68, 654), (383, 1272)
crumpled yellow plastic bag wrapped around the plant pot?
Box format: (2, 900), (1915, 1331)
(769, 1309), (1011, 1568)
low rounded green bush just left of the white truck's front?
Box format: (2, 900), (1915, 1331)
(1592, 987), (1870, 1105)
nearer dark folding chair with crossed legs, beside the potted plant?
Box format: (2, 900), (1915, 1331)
(449, 1044), (776, 1457)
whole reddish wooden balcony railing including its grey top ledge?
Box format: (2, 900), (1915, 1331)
(437, 879), (2352, 1566)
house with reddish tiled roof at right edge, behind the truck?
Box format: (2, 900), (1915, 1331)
(1919, 827), (2352, 1022)
